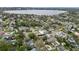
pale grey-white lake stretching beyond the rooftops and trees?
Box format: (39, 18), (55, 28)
(4, 10), (66, 15)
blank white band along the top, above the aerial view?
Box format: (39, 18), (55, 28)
(0, 0), (79, 7)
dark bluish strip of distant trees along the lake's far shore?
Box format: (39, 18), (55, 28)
(0, 7), (79, 11)
